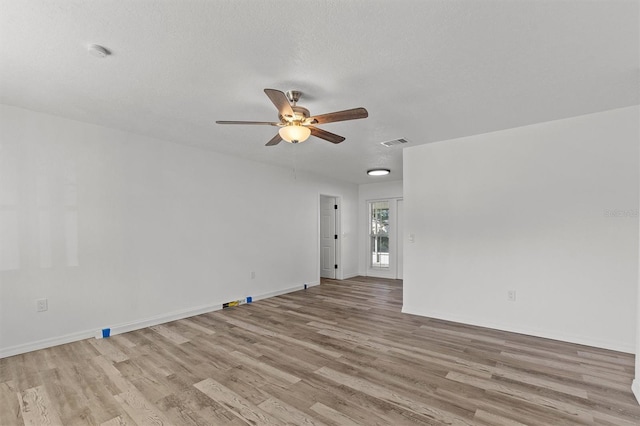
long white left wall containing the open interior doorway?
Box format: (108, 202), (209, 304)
(0, 106), (358, 356)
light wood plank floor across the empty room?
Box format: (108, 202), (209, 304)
(0, 277), (640, 426)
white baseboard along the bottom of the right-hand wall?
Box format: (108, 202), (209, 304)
(402, 306), (635, 354)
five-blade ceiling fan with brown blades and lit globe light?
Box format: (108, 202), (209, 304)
(216, 89), (369, 146)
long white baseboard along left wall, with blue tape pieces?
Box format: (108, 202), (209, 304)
(0, 281), (320, 359)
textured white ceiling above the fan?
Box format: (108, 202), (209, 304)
(0, 0), (640, 183)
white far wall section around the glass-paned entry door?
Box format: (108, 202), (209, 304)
(358, 177), (402, 275)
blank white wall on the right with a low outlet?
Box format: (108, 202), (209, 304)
(403, 106), (639, 352)
